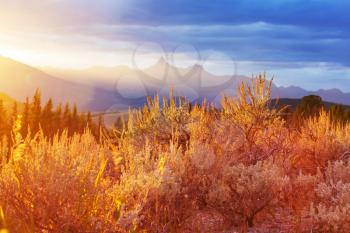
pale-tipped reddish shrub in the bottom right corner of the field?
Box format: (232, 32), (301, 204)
(303, 161), (350, 233)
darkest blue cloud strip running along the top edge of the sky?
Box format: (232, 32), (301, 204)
(114, 0), (350, 28)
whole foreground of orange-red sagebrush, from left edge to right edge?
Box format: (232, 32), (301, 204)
(0, 75), (350, 233)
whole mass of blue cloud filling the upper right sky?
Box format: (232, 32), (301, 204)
(65, 0), (350, 65)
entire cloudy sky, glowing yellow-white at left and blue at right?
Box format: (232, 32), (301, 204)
(0, 0), (350, 92)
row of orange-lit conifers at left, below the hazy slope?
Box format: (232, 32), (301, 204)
(0, 90), (105, 138)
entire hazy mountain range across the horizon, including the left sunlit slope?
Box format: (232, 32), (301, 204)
(0, 57), (350, 111)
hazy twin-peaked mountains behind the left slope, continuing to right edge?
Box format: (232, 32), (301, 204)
(45, 58), (350, 106)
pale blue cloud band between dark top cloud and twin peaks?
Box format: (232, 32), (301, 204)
(74, 22), (350, 65)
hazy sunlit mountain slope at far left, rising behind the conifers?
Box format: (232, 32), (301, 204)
(0, 57), (106, 108)
